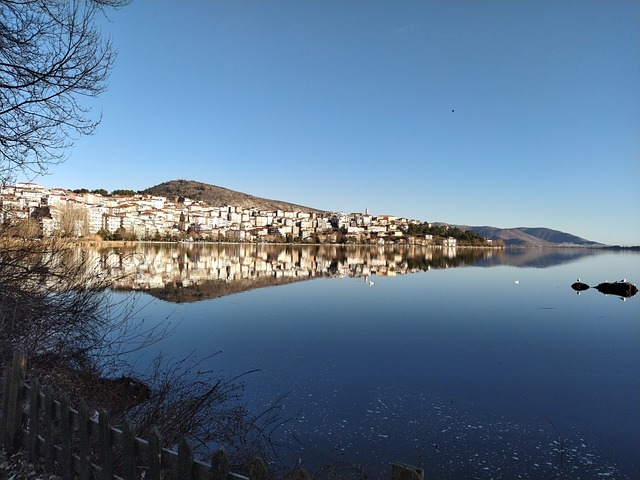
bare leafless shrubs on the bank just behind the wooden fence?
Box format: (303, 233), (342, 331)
(0, 232), (296, 467)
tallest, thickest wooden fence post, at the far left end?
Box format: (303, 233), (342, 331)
(3, 352), (27, 453)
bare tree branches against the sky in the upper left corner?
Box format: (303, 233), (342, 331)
(0, 0), (129, 183)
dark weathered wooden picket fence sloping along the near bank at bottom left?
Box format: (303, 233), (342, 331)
(0, 353), (424, 480)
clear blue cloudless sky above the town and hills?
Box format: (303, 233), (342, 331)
(27, 0), (640, 245)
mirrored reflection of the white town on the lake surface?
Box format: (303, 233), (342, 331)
(91, 243), (600, 302)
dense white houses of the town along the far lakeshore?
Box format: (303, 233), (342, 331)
(0, 182), (456, 246)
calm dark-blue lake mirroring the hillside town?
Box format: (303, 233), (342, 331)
(101, 244), (640, 479)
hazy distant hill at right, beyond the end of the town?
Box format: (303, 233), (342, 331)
(438, 225), (604, 247)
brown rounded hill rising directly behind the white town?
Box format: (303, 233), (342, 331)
(141, 180), (323, 213)
